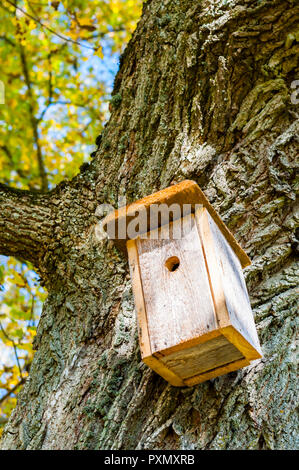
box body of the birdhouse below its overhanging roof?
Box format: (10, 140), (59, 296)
(127, 208), (260, 386)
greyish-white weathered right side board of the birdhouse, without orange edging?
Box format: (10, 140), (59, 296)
(207, 214), (261, 357)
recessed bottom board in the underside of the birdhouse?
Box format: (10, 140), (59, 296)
(160, 335), (244, 380)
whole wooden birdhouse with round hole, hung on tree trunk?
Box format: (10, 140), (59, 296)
(103, 180), (261, 386)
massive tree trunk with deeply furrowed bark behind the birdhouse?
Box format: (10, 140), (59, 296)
(0, 0), (299, 449)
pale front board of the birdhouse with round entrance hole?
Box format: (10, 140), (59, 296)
(137, 214), (217, 353)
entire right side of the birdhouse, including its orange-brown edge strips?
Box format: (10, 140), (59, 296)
(195, 208), (262, 360)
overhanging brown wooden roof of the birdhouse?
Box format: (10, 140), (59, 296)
(103, 180), (251, 267)
